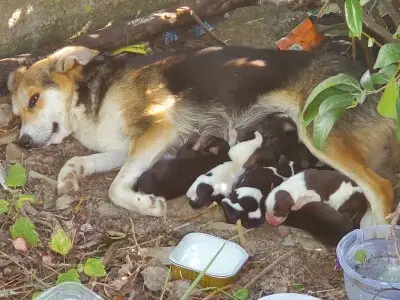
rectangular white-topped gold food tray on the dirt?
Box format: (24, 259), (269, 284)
(169, 233), (249, 287)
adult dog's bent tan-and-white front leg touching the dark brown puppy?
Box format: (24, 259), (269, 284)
(108, 120), (177, 217)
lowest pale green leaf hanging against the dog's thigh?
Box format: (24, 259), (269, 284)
(313, 108), (346, 150)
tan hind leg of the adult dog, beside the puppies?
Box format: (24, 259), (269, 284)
(299, 132), (393, 225)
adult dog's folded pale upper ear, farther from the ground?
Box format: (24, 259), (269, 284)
(51, 46), (100, 72)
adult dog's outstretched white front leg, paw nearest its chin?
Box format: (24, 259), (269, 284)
(57, 151), (127, 194)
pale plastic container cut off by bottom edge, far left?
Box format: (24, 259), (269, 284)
(35, 282), (103, 300)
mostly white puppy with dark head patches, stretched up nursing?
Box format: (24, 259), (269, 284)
(186, 131), (263, 208)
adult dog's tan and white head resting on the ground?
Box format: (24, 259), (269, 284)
(8, 46), (99, 148)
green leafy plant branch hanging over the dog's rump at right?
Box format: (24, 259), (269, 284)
(302, 0), (400, 149)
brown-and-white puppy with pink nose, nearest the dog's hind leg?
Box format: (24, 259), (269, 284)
(265, 169), (368, 226)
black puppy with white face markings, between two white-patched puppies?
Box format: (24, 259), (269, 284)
(221, 156), (298, 228)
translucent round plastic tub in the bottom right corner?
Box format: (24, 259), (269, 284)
(336, 225), (400, 300)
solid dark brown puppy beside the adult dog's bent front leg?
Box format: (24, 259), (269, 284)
(134, 135), (230, 200)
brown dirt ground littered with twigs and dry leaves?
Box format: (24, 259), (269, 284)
(0, 21), (354, 300)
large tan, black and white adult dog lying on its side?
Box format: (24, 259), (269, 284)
(8, 46), (398, 224)
